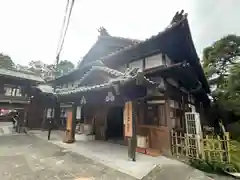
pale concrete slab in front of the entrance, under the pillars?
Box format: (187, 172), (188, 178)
(31, 131), (186, 179)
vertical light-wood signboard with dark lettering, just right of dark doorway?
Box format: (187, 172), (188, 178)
(124, 101), (133, 137)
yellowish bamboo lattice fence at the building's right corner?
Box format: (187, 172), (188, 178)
(171, 131), (231, 163)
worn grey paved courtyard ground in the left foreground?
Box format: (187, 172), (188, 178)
(0, 135), (135, 180)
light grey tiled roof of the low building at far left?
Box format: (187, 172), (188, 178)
(0, 68), (44, 82)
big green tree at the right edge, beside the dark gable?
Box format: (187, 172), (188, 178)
(203, 35), (240, 122)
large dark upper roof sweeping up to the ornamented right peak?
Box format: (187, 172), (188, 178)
(50, 11), (209, 92)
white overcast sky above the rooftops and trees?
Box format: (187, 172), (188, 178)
(0, 0), (240, 65)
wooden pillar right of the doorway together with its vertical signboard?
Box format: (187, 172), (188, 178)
(124, 101), (137, 161)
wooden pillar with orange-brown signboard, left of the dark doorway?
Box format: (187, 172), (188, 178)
(63, 104), (77, 143)
